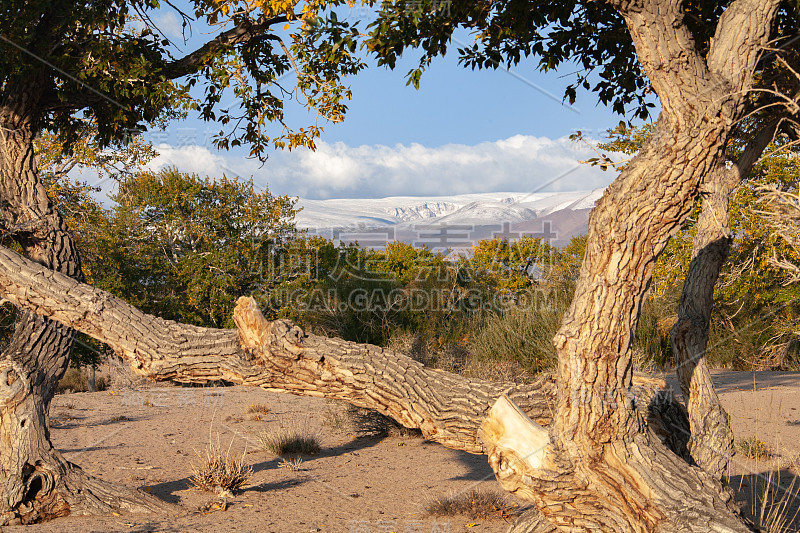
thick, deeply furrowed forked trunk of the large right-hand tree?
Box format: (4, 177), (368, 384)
(482, 0), (779, 533)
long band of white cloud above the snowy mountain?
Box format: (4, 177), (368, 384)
(144, 135), (615, 199)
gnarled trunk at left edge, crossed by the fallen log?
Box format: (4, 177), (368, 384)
(0, 81), (166, 524)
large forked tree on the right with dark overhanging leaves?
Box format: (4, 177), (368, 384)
(369, 0), (797, 531)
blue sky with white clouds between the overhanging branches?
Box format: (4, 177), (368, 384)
(125, 6), (648, 198)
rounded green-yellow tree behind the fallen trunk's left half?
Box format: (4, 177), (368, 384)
(91, 168), (296, 327)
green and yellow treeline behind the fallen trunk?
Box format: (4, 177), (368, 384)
(2, 164), (800, 379)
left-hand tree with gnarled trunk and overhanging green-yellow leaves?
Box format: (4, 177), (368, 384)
(0, 0), (362, 523)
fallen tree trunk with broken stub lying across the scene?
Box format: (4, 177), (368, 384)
(0, 243), (688, 454)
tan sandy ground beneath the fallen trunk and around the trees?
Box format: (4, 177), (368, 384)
(9, 372), (800, 533)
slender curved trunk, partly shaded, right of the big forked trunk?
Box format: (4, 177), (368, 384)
(671, 121), (779, 478)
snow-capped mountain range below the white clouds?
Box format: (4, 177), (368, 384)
(297, 189), (603, 248)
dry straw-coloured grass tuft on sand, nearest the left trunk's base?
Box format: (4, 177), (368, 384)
(190, 434), (253, 497)
